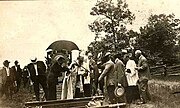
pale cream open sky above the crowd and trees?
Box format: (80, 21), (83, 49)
(0, 0), (180, 67)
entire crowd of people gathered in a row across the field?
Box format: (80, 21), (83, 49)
(0, 50), (150, 103)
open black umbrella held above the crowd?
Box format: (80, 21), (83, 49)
(46, 40), (79, 51)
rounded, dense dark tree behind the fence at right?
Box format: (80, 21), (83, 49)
(138, 14), (180, 63)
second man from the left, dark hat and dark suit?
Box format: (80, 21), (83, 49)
(11, 60), (22, 92)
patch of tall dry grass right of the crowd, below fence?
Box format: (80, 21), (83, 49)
(149, 79), (180, 108)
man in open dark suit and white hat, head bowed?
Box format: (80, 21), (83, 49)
(27, 58), (48, 101)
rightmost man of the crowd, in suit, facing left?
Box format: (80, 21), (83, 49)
(135, 50), (150, 103)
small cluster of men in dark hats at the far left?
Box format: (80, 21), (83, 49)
(0, 60), (30, 99)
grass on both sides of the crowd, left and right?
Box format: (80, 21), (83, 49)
(0, 76), (180, 108)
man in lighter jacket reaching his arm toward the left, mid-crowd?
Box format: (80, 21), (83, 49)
(98, 52), (116, 104)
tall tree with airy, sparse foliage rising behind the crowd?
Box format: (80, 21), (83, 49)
(88, 0), (135, 55)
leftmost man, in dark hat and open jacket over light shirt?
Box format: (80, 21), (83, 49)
(3, 60), (14, 99)
